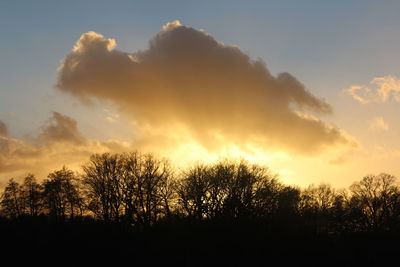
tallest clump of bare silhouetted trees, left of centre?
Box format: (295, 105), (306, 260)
(82, 152), (174, 225)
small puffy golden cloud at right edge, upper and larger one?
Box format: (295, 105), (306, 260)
(344, 75), (400, 104)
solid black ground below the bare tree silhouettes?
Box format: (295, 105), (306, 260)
(0, 217), (400, 266)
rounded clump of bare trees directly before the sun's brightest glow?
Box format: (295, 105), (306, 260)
(177, 161), (281, 219)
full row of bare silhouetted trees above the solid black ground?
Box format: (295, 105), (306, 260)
(0, 152), (400, 236)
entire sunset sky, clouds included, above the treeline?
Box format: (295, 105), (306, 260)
(0, 0), (400, 187)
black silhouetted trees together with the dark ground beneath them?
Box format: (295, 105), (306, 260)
(0, 152), (400, 266)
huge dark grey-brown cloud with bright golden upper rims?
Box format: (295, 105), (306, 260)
(57, 21), (354, 155)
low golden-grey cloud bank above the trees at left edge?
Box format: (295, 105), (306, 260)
(0, 112), (132, 179)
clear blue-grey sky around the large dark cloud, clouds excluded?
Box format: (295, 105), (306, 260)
(0, 0), (400, 187)
